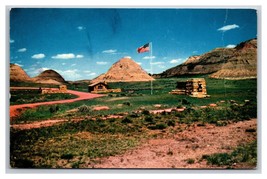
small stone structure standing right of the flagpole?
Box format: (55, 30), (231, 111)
(170, 78), (209, 98)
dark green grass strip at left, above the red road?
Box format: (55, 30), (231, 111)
(10, 90), (77, 105)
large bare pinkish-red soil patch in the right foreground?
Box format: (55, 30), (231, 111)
(91, 119), (257, 169)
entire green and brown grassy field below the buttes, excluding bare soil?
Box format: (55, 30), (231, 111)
(10, 76), (257, 168)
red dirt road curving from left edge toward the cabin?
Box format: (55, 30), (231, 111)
(9, 90), (104, 120)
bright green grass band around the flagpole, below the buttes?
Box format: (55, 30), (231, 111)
(14, 78), (257, 122)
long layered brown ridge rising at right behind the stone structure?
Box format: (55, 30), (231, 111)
(155, 39), (257, 79)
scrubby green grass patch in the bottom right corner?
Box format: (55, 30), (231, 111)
(202, 140), (257, 168)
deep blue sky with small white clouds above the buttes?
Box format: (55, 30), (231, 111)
(9, 8), (257, 81)
